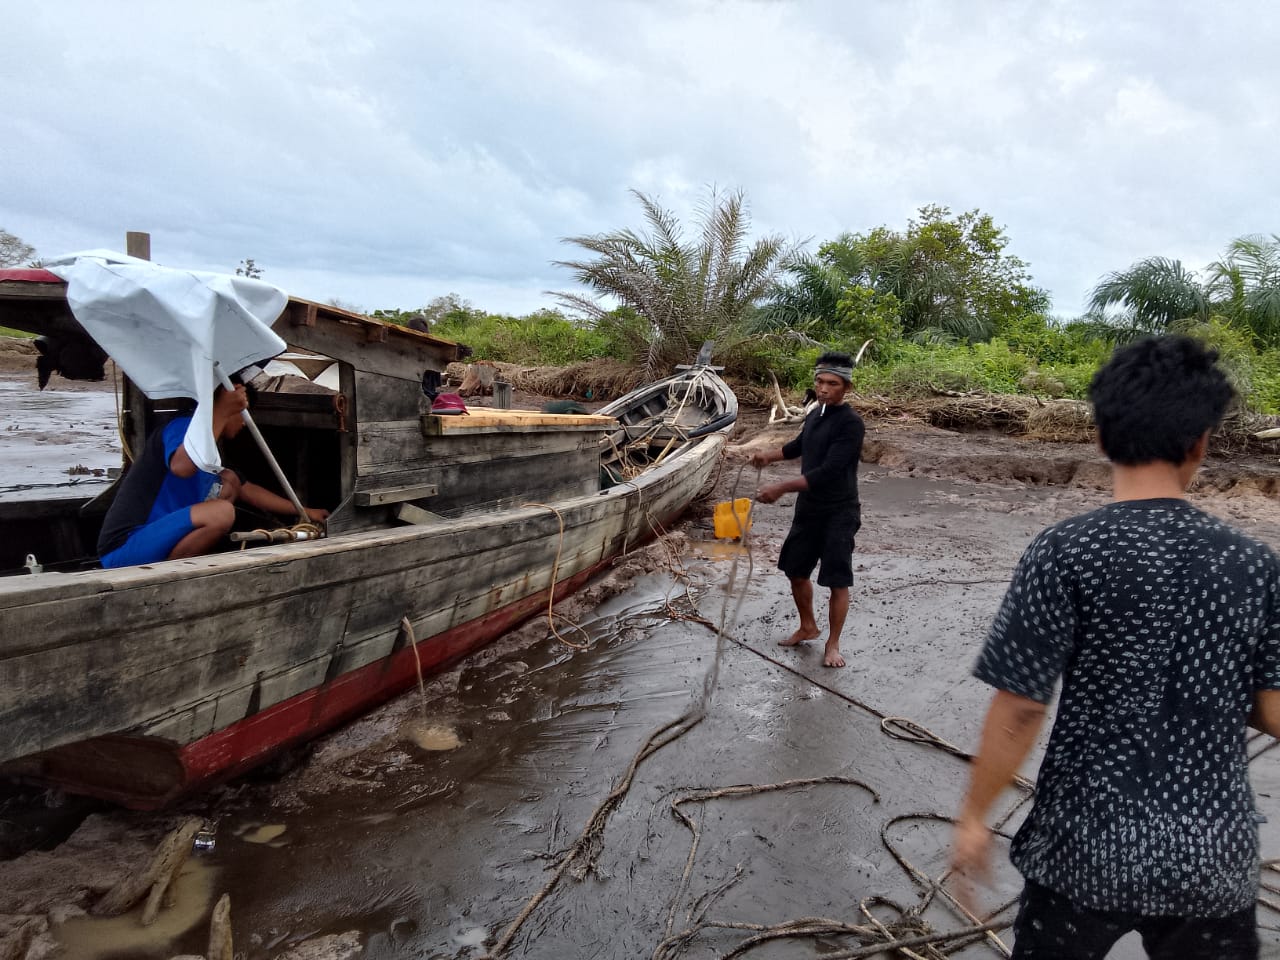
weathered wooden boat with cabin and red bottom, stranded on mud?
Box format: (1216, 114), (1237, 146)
(0, 264), (736, 809)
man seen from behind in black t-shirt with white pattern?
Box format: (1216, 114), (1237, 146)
(952, 337), (1280, 960)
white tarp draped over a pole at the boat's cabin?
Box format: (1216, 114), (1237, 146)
(44, 250), (289, 474)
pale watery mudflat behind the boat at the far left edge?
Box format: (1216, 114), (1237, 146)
(0, 376), (120, 499)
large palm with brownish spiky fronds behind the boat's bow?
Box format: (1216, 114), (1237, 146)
(554, 189), (791, 375)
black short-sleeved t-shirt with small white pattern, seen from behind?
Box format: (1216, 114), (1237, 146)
(974, 499), (1280, 916)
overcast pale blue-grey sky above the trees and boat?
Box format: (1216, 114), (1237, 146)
(0, 0), (1280, 316)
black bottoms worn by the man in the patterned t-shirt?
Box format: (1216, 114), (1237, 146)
(1012, 881), (1258, 960)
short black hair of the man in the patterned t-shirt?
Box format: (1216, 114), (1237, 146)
(1089, 337), (1234, 466)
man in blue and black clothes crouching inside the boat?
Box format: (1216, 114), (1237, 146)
(97, 385), (329, 567)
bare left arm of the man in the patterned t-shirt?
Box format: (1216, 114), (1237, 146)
(951, 690), (1047, 877)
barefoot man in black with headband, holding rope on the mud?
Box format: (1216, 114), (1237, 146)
(751, 352), (865, 667)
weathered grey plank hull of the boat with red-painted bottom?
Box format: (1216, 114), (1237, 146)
(0, 433), (724, 809)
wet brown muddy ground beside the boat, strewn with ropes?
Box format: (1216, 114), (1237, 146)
(0, 363), (1280, 960)
